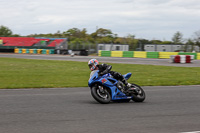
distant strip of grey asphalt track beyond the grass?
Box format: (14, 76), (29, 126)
(0, 54), (200, 67)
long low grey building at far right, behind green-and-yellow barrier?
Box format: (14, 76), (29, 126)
(144, 44), (199, 52)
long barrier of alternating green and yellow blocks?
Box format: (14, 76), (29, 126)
(98, 50), (200, 60)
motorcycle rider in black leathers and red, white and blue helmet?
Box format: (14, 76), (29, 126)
(88, 59), (131, 89)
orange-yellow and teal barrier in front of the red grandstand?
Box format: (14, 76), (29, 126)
(14, 48), (54, 54)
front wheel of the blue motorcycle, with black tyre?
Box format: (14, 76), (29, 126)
(91, 85), (111, 104)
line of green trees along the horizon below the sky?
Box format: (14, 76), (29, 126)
(0, 25), (200, 51)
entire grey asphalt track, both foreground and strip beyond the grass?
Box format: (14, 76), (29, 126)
(0, 54), (200, 133)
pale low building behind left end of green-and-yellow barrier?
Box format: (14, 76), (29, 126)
(97, 44), (129, 51)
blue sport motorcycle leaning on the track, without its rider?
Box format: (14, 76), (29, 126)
(88, 70), (145, 104)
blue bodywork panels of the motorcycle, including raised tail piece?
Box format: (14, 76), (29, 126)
(88, 70), (133, 101)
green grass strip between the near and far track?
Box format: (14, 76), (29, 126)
(0, 58), (200, 88)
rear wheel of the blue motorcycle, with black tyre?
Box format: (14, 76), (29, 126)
(131, 84), (146, 102)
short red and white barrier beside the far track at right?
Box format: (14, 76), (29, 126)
(171, 55), (194, 63)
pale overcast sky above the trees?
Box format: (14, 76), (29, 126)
(0, 0), (200, 41)
